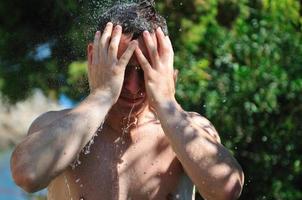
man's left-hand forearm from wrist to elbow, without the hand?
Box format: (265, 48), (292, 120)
(11, 91), (112, 192)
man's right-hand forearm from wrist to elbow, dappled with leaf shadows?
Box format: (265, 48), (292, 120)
(156, 100), (243, 200)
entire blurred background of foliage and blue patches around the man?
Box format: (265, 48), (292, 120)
(0, 0), (302, 200)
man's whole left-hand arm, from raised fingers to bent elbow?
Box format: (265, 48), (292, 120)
(11, 23), (137, 192)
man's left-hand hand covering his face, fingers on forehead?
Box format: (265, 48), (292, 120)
(88, 22), (137, 103)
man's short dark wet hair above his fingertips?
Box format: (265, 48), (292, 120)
(98, 0), (168, 39)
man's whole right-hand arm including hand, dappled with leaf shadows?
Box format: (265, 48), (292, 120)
(136, 28), (244, 200)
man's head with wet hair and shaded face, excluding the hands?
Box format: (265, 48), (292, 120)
(88, 1), (168, 114)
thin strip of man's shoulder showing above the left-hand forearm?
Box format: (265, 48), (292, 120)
(27, 109), (71, 135)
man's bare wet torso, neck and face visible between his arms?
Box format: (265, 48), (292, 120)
(48, 30), (184, 200)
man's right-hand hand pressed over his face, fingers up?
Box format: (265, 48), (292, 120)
(135, 28), (175, 108)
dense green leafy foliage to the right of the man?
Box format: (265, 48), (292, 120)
(173, 0), (302, 199)
